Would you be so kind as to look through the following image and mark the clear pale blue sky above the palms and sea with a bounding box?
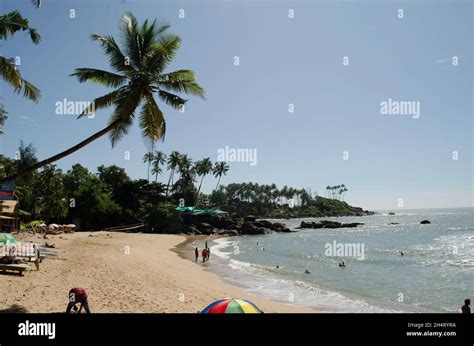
[0,0,474,210]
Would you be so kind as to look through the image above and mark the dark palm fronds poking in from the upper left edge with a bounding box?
[0,11,41,102]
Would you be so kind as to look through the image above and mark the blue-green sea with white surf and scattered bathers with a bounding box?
[202,208,474,313]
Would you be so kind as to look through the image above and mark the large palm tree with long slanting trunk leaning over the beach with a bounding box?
[0,13,204,182]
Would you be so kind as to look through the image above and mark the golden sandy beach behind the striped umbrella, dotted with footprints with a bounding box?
[0,232,311,313]
